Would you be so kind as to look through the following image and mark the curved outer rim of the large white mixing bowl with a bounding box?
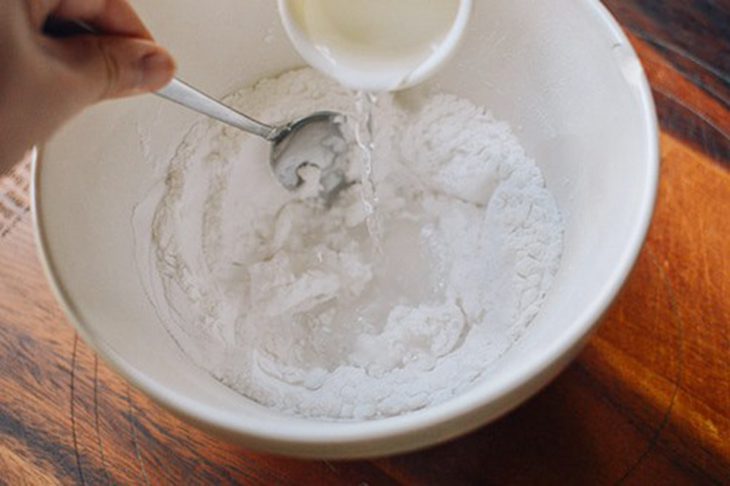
[31,0,660,458]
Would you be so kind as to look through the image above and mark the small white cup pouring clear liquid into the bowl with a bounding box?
[278,0,472,92]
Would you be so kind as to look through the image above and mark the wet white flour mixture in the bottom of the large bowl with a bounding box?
[141,69,562,419]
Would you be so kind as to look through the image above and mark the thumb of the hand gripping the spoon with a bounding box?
[54,36,175,103]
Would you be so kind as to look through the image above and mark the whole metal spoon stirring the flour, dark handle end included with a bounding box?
[43,17,350,197]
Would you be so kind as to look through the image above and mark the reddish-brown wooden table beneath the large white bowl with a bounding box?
[0,0,730,484]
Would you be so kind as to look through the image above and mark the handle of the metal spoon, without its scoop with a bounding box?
[43,17,280,141]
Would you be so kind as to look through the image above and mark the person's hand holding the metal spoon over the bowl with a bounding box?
[0,0,175,174]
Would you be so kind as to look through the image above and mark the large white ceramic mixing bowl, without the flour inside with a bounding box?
[34,0,659,457]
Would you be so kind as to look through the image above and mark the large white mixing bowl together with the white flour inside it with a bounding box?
[34,0,658,457]
